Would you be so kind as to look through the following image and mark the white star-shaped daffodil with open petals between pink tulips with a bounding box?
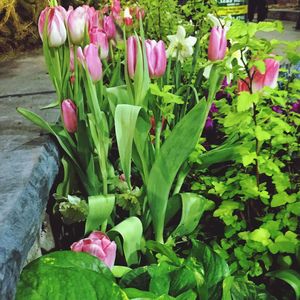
[167,25,197,62]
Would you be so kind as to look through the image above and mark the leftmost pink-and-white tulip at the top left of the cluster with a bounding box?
[38,6,67,47]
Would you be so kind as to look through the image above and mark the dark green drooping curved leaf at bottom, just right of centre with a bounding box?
[191,240,229,289]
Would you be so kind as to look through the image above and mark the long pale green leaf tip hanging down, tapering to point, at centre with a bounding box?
[115,104,141,186]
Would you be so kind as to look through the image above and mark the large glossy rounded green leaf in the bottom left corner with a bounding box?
[16,251,128,300]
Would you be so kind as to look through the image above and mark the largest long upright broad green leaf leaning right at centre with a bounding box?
[147,101,206,242]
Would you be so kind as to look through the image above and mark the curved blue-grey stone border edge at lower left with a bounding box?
[0,136,60,300]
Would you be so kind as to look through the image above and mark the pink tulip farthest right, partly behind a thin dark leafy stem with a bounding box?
[251,58,279,93]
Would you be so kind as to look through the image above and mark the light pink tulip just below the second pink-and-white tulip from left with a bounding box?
[77,44,102,82]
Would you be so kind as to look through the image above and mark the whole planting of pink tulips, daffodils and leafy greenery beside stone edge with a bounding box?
[17,0,300,300]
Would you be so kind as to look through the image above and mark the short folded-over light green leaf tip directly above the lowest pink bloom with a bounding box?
[85,195,115,233]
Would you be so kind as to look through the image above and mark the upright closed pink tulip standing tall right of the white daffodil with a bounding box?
[208,26,227,61]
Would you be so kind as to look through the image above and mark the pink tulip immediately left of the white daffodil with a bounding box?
[145,40,167,78]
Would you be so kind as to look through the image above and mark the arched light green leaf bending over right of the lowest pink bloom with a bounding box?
[108,217,143,266]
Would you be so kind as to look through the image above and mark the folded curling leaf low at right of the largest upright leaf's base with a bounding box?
[172,193,208,236]
